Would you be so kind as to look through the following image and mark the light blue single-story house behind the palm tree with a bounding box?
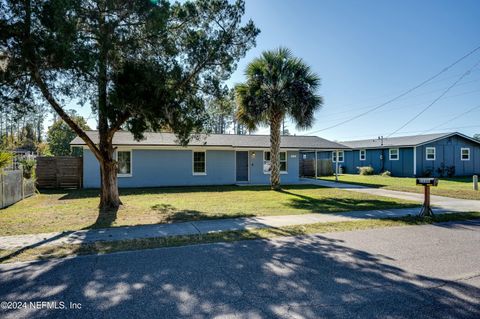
[70,131,347,188]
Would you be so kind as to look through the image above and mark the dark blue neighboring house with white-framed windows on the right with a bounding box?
[318,132,480,177]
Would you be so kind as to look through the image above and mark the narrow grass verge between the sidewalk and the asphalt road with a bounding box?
[0,212,480,263]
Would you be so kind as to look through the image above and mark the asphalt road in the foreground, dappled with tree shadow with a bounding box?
[0,221,480,319]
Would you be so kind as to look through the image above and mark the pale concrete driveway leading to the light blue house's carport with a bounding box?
[301,178,480,212]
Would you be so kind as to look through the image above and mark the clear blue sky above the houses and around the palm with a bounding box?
[72,0,480,141]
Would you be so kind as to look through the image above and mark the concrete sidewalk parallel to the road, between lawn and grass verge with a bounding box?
[0,208,449,250]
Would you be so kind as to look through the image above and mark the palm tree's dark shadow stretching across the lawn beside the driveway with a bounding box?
[280,189,418,213]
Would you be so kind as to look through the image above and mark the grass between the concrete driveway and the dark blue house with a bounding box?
[320,174,480,199]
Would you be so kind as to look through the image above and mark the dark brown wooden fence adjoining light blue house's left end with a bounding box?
[36,156,83,188]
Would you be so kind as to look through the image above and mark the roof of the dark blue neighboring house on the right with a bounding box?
[340,132,480,149]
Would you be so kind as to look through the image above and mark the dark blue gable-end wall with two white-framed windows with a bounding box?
[417,136,480,176]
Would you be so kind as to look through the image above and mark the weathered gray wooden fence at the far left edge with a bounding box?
[0,170,35,208]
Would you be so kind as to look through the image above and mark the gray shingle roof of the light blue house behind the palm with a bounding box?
[70,131,348,150]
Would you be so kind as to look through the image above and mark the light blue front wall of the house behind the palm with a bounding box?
[83,149,299,188]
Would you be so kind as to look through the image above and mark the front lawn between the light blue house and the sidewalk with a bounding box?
[0,185,418,236]
